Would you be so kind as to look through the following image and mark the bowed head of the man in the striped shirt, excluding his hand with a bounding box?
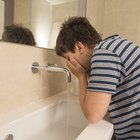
[55,17,102,70]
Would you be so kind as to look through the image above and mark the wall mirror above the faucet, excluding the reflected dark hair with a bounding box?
[0,0,85,49]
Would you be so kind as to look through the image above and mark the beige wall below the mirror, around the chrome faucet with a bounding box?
[0,42,68,117]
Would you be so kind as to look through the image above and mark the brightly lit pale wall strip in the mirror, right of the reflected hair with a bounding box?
[30,0,52,48]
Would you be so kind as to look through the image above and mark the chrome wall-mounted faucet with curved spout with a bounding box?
[31,62,71,83]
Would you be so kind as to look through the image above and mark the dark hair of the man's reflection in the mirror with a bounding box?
[1,24,36,46]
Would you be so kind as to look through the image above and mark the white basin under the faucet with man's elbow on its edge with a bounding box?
[0,93,113,140]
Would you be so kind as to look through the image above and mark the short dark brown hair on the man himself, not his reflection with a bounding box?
[55,17,102,56]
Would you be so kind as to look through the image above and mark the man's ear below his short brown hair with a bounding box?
[75,41,86,54]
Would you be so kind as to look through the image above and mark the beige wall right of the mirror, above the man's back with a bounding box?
[87,0,140,44]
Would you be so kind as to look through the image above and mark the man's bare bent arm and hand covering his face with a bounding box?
[67,60,111,123]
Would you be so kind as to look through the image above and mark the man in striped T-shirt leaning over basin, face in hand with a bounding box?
[55,17,140,140]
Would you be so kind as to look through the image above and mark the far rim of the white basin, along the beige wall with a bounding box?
[0,92,79,131]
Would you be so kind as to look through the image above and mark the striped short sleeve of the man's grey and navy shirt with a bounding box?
[87,49,123,94]
